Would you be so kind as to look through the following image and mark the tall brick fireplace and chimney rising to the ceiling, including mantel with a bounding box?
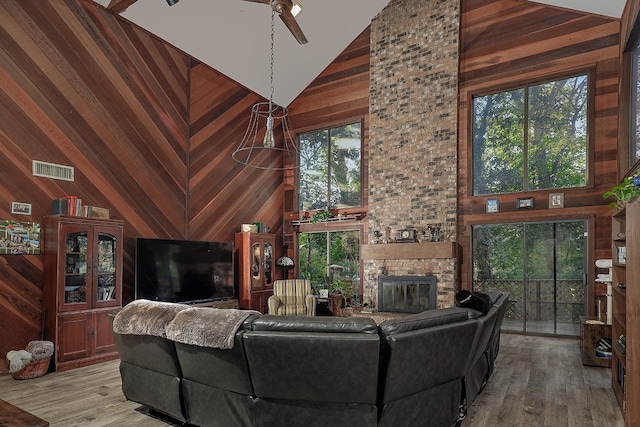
[361,0,460,308]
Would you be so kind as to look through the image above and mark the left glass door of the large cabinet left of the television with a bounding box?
[64,231,89,304]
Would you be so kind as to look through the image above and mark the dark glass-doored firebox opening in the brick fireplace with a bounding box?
[378,276,436,313]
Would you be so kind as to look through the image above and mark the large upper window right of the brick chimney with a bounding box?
[472,75,589,195]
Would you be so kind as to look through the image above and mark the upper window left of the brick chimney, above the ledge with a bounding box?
[298,122,362,211]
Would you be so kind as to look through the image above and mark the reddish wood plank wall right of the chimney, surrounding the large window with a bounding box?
[458,0,620,312]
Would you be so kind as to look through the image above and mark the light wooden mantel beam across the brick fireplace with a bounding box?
[360,242,459,260]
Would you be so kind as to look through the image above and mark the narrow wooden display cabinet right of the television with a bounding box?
[235,232,276,313]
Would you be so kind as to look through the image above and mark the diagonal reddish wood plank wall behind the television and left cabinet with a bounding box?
[0,0,283,371]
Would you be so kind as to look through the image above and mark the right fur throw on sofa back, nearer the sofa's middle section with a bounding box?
[167,307,260,349]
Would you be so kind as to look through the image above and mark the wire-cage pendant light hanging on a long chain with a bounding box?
[232,10,300,170]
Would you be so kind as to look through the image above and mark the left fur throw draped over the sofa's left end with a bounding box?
[113,299,190,338]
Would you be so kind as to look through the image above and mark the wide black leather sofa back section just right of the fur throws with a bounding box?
[242,315,380,410]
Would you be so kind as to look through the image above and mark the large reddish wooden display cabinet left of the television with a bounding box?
[42,215,123,372]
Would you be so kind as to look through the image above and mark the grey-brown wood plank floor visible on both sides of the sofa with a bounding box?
[0,334,624,427]
